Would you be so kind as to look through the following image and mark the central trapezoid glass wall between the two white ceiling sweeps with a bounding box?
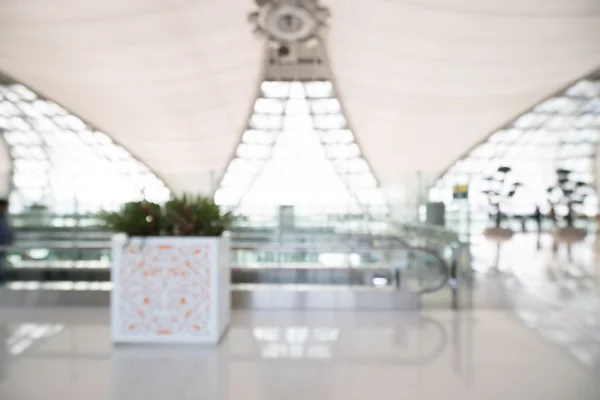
[215,81,387,218]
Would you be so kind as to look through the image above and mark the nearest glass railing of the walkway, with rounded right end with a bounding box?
[4,242,449,293]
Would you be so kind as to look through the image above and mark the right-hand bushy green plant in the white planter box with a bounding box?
[164,194,233,236]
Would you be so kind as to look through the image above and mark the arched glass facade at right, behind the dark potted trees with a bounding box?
[430,79,600,215]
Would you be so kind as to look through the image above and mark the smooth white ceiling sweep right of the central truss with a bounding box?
[327,0,600,185]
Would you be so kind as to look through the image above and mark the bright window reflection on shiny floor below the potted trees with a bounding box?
[472,234,600,370]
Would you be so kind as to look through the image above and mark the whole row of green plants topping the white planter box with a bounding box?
[98,194,233,236]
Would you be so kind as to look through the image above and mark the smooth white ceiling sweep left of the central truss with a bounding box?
[0,0,263,191]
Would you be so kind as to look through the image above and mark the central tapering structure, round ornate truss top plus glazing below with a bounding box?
[215,0,387,222]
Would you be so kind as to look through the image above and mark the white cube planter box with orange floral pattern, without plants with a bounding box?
[110,235,231,344]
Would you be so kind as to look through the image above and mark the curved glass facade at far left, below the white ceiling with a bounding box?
[0,79,170,214]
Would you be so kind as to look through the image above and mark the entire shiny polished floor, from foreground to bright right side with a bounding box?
[0,231,600,400]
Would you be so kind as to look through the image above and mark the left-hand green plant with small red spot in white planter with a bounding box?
[98,201,163,236]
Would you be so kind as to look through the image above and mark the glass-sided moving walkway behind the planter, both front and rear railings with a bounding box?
[1,211,468,293]
